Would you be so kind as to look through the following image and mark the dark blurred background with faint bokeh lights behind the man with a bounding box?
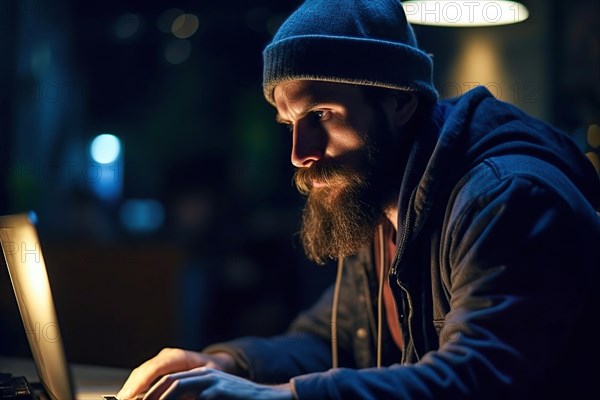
[0,0,600,367]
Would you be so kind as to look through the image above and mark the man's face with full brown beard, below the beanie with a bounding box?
[274,81,397,263]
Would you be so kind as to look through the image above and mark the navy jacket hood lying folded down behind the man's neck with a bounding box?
[398,86,600,238]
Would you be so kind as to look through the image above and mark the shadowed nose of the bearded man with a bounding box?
[291,121,326,168]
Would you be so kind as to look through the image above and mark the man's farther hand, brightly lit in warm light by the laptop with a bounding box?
[117,348,236,400]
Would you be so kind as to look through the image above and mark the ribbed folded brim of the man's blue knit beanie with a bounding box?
[263,35,438,104]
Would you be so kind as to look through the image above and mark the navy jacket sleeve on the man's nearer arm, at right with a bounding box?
[292,168,600,399]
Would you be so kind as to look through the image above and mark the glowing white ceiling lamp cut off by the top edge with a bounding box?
[402,0,529,27]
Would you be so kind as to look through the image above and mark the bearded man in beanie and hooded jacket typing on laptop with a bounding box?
[119,0,600,399]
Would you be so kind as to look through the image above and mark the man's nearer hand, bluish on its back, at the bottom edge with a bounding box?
[139,367,294,400]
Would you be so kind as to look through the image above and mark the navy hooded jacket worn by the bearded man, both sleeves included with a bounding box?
[205,87,600,400]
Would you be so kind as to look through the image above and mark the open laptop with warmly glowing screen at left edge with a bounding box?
[0,212,131,400]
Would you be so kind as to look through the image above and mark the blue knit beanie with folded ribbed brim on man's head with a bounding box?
[263,0,438,104]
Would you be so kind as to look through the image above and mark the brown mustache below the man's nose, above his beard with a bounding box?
[293,161,366,196]
